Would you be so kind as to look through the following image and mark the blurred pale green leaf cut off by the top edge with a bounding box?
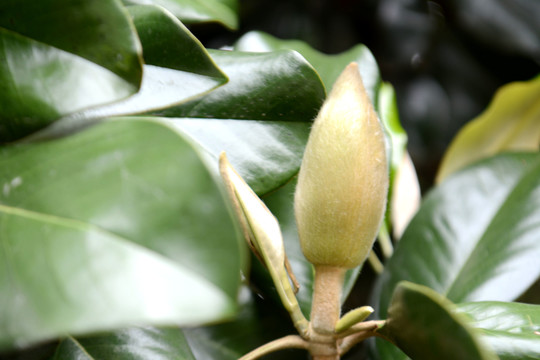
[123,0,238,29]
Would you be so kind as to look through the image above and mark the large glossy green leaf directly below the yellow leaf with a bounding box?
[374,154,540,359]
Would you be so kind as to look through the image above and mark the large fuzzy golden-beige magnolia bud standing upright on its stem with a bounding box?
[294,63,389,268]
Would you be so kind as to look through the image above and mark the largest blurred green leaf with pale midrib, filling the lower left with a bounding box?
[0,119,243,347]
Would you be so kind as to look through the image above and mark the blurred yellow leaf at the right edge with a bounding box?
[437,76,540,182]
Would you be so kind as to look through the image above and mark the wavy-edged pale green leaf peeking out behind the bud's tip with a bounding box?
[234,31,381,98]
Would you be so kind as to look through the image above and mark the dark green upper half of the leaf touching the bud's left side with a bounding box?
[154,50,325,122]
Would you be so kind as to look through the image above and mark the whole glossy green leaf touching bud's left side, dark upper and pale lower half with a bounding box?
[149,51,324,194]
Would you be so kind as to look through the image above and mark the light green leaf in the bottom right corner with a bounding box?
[457,302,540,360]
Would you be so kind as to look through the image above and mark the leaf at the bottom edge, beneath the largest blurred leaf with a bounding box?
[51,327,195,360]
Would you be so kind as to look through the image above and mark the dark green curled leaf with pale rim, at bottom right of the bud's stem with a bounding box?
[381,282,497,360]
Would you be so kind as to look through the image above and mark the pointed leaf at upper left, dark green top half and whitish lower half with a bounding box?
[47,5,227,125]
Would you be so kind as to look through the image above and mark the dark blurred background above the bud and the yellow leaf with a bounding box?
[193,0,540,190]
